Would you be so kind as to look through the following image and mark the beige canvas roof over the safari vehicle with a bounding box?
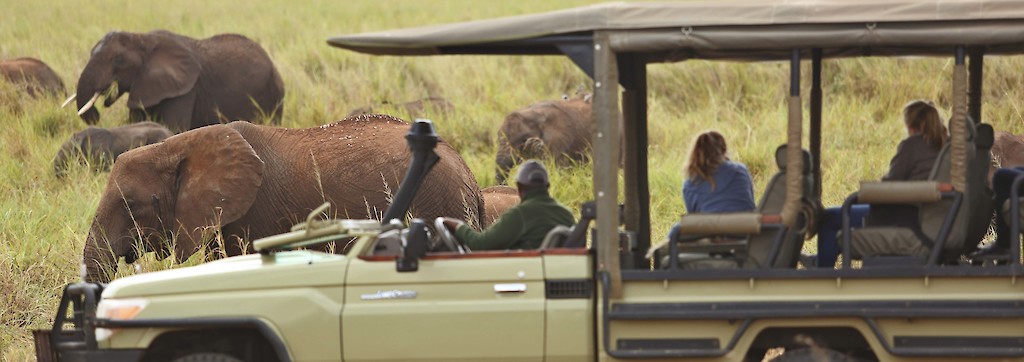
[328,0,1024,61]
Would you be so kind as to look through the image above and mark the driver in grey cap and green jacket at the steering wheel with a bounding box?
[444,160,575,251]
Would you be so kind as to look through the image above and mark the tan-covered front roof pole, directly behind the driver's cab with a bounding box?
[593,32,623,299]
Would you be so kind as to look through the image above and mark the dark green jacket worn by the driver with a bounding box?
[455,189,575,251]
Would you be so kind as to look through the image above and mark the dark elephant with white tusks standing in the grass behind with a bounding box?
[76,31,285,132]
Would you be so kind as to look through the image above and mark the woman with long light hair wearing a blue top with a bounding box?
[683,131,754,213]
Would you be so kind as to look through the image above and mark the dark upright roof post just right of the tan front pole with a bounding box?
[617,54,650,269]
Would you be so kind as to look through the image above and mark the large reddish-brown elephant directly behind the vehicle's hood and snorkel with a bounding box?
[83,115,483,281]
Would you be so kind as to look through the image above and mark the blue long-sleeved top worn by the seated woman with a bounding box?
[683,161,755,213]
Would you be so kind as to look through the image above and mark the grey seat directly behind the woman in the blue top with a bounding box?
[743,144,814,268]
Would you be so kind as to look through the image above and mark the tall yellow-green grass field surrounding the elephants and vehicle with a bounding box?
[0,0,1024,361]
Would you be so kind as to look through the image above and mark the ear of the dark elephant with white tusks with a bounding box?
[128,35,203,108]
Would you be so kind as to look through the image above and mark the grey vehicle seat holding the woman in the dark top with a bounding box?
[850,119,993,267]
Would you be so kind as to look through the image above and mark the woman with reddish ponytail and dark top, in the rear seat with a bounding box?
[803,99,948,268]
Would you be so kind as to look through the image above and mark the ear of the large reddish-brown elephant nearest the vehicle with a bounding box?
[164,125,264,262]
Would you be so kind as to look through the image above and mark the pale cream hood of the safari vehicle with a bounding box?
[102,251,348,299]
